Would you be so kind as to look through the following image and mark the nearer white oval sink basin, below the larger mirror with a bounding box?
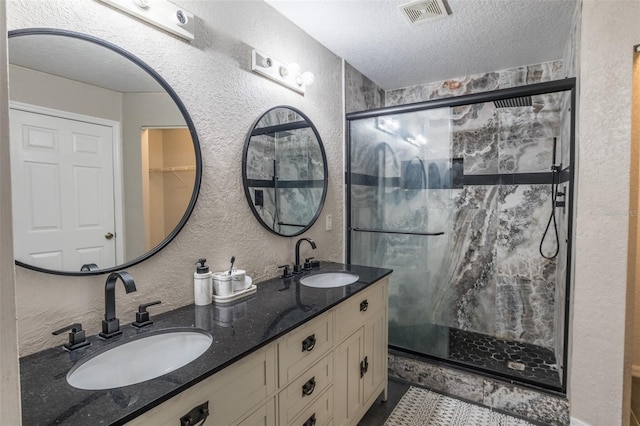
[67,328,213,390]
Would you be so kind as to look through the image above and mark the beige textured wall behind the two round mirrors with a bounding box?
[3,0,343,355]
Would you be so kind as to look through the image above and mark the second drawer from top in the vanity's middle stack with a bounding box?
[278,353,333,423]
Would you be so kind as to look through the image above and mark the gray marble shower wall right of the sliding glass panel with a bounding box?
[441,91,561,348]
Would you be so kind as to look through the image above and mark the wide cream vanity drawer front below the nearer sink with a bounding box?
[128,345,276,426]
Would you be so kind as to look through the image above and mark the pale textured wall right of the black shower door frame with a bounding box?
[570,0,640,426]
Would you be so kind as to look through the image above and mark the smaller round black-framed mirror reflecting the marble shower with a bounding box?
[242,106,327,237]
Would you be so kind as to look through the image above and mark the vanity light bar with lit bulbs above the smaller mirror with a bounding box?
[251,49,315,95]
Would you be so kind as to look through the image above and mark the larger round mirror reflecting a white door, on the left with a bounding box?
[9,28,202,275]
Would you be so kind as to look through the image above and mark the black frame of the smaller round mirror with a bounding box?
[242,105,329,237]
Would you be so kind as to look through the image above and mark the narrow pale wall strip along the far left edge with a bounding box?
[0,2,20,425]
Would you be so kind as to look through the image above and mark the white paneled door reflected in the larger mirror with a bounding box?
[9,109,116,271]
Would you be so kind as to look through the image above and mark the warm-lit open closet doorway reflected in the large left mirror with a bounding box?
[141,127,196,250]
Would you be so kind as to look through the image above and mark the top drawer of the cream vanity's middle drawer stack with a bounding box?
[278,313,333,387]
